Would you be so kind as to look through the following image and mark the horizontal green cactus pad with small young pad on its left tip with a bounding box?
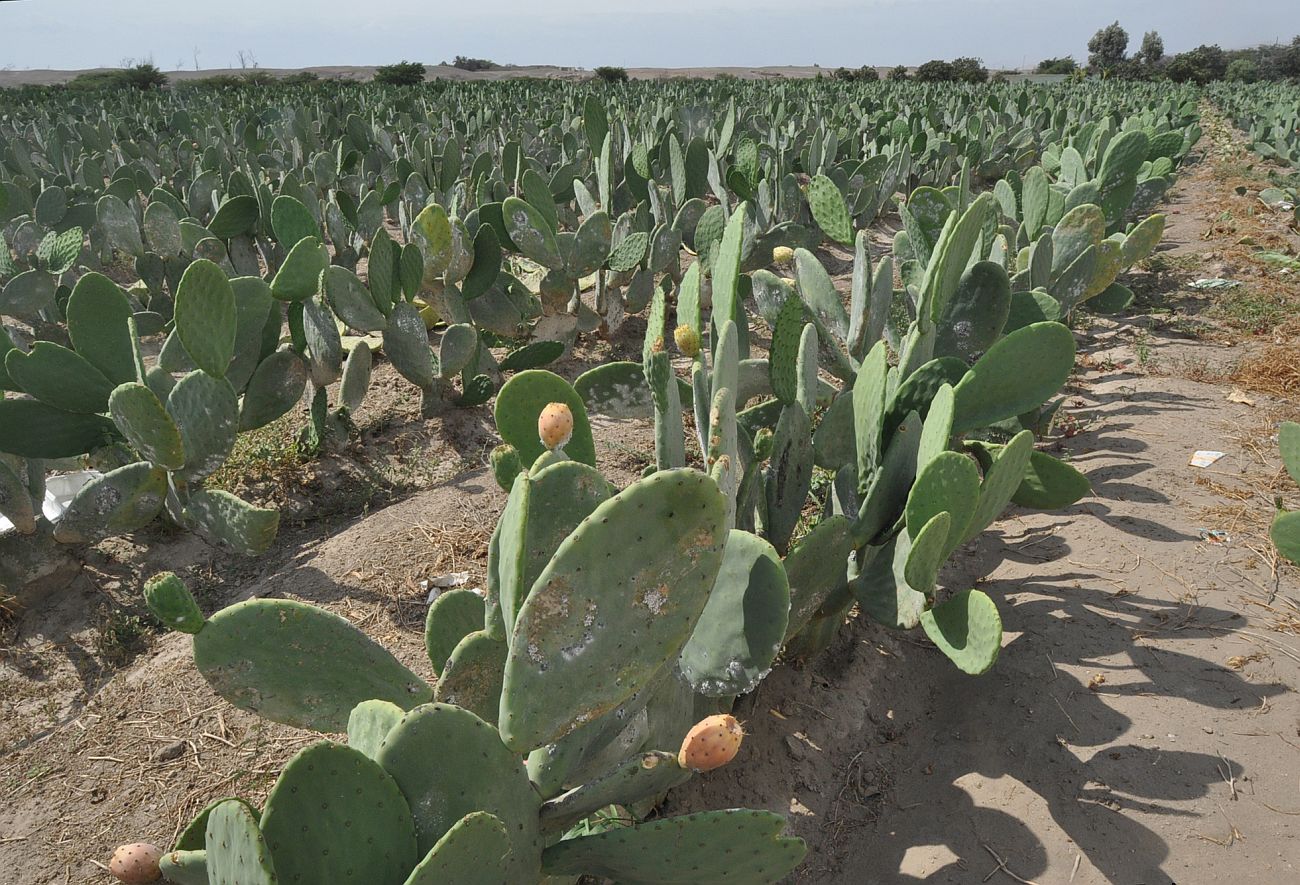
[194,599,433,732]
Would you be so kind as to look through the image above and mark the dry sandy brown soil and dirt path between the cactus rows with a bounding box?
[0,107,1300,885]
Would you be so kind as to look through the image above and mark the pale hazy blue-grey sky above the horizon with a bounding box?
[0,0,1300,70]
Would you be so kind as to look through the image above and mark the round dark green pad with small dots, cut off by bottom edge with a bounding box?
[261,741,420,885]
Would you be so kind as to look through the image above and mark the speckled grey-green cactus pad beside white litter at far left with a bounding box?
[55,461,166,543]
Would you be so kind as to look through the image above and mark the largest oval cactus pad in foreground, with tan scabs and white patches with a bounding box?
[499,469,727,751]
